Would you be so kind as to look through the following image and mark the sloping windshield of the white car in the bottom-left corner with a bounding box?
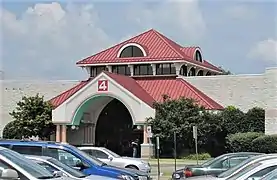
[0,149,53,179]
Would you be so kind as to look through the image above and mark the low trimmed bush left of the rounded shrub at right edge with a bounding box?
[226,132,263,152]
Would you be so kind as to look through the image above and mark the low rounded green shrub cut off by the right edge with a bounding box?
[252,135,277,153]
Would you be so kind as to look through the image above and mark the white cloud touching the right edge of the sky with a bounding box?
[248,39,277,62]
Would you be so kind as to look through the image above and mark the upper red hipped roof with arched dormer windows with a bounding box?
[76,29,221,71]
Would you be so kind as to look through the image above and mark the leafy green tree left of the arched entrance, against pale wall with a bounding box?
[7,94,54,138]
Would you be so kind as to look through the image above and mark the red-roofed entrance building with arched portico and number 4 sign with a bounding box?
[50,29,226,156]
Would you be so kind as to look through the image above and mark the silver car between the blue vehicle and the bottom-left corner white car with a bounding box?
[25,155,115,180]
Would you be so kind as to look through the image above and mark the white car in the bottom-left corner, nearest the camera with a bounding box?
[0,147,72,180]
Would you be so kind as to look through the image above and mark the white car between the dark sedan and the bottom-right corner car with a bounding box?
[227,158,277,180]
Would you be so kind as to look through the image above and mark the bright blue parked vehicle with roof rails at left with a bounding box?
[0,140,140,180]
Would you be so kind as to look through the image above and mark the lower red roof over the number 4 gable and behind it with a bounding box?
[50,72,223,109]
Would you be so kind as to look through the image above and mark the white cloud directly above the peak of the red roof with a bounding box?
[125,0,206,39]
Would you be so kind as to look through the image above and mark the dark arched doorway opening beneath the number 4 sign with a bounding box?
[95,99,142,156]
